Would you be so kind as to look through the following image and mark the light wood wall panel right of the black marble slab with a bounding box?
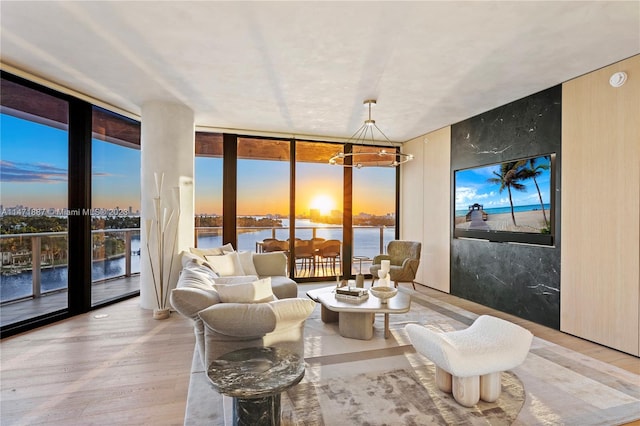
[560,56,640,355]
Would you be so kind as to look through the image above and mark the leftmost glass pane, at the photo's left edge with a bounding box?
[0,78,70,328]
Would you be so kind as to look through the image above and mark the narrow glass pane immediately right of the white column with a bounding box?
[194,132,223,248]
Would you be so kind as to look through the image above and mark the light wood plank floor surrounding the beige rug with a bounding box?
[0,284,640,426]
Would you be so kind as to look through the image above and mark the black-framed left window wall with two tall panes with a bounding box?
[0,71,140,337]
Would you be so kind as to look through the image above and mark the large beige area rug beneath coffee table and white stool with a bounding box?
[185,284,640,426]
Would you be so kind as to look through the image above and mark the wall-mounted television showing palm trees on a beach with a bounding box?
[453,154,555,245]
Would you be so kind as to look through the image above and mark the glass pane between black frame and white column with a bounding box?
[91,107,140,305]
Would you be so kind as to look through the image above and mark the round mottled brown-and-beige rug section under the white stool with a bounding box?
[282,365,525,426]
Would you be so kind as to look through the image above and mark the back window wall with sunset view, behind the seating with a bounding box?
[195,133,397,281]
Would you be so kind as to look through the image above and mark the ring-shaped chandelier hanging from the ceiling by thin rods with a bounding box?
[329,99,413,169]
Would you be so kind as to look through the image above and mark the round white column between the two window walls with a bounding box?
[140,101,195,309]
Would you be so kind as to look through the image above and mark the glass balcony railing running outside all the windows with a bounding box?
[0,226,395,304]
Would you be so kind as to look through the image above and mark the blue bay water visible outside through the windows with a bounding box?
[0,223,395,302]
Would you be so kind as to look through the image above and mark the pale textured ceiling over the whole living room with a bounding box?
[0,0,640,142]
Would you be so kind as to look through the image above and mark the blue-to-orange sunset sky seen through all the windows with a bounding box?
[0,114,395,215]
